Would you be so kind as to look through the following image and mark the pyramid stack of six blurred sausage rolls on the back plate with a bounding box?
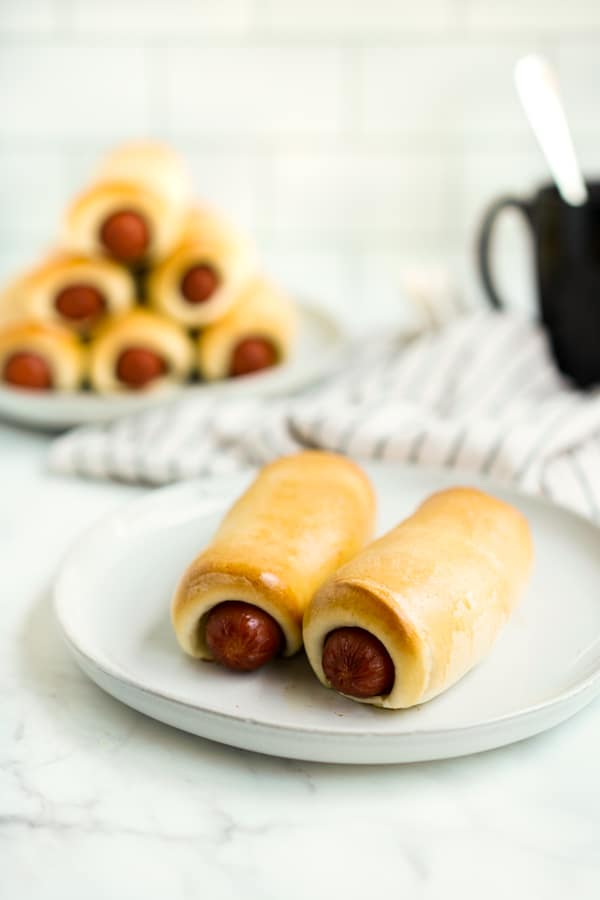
[0,142,296,394]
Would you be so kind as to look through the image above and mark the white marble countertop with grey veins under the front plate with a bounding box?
[0,425,600,900]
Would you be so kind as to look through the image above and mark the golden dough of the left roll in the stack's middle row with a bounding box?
[0,253,135,333]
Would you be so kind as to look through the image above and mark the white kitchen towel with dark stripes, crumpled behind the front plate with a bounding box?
[50,312,600,521]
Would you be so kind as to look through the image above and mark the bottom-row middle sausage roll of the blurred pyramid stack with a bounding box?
[90,309,194,394]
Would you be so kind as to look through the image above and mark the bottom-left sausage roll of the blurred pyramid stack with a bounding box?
[0,321,86,391]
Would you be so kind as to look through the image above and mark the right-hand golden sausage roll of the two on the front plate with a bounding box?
[304,488,533,709]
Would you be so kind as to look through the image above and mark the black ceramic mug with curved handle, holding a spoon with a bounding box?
[478,182,600,387]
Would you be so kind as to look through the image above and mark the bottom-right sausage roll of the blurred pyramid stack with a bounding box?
[198,278,297,381]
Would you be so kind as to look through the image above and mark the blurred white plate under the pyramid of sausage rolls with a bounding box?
[0,304,345,429]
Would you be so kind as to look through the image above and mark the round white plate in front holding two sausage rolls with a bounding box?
[55,463,600,763]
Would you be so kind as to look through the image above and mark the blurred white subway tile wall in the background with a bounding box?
[0,0,600,330]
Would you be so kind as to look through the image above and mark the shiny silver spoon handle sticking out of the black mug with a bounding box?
[515,54,588,206]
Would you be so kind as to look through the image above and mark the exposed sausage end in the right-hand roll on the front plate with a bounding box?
[322,628,395,698]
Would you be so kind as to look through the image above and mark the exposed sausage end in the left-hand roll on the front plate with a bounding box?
[206,600,283,672]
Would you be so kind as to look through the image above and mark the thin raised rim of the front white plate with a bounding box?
[52,459,600,752]
